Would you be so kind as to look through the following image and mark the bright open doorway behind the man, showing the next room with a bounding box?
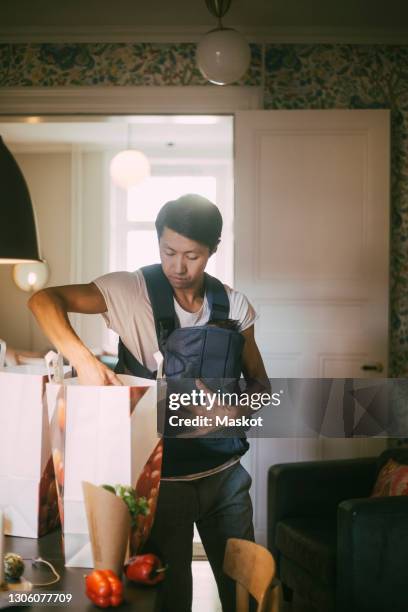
[0,115,234,353]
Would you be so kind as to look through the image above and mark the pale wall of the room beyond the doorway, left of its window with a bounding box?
[0,151,108,350]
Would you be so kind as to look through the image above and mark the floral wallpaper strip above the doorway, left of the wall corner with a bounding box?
[0,43,261,87]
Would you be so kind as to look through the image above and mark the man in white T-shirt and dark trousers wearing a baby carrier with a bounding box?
[29,195,268,612]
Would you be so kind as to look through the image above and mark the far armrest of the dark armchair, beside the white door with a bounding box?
[268,457,376,554]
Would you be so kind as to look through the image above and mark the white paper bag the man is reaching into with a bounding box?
[47,375,161,567]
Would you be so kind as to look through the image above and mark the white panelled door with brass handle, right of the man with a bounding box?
[234,110,390,542]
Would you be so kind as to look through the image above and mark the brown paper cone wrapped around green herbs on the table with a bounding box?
[82,482,130,576]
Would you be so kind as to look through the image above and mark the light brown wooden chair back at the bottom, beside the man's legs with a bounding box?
[223,538,279,612]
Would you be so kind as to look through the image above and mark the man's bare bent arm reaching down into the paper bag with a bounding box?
[28,283,121,385]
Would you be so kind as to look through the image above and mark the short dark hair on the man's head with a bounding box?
[156,193,222,253]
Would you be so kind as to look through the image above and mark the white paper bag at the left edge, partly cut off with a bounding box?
[0,341,68,538]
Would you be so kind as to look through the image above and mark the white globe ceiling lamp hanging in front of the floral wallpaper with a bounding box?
[197,28,251,85]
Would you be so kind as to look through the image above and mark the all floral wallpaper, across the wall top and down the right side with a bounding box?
[0,43,408,377]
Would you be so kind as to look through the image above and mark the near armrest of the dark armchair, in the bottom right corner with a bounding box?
[336,496,408,612]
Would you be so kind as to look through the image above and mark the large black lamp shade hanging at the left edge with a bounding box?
[0,136,40,264]
